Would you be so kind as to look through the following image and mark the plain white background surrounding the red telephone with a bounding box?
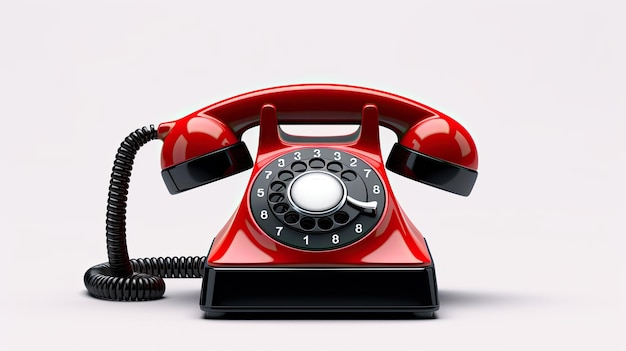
[0,0,626,350]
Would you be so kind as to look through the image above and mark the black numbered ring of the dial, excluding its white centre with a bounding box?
[250,148,385,251]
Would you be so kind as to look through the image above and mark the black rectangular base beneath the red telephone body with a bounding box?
[200,266,439,318]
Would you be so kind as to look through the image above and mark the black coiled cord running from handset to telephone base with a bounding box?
[84,125,206,301]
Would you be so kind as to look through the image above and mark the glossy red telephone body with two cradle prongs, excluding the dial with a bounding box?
[207,105,431,267]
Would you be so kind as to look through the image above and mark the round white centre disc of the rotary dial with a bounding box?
[287,171,346,214]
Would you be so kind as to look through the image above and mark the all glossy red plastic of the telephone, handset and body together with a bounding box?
[158,84,478,267]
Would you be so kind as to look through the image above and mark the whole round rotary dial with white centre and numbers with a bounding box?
[250,148,385,251]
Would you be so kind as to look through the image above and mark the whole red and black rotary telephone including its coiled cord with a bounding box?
[85,84,478,317]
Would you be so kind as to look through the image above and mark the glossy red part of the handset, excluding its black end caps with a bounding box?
[159,84,478,169]
